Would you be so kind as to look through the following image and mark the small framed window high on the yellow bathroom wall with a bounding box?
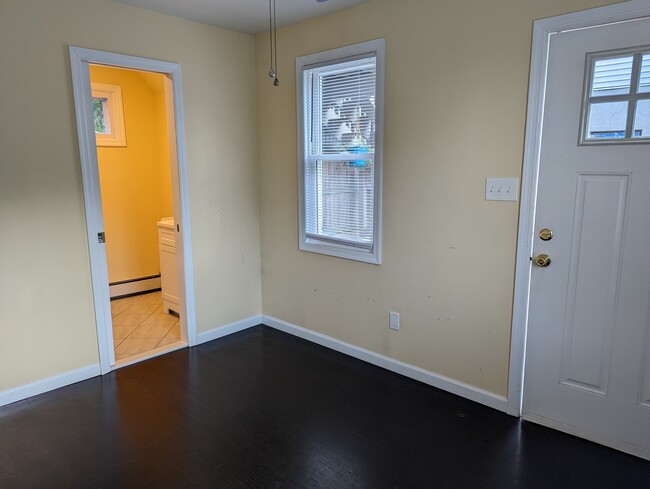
[91,83,126,146]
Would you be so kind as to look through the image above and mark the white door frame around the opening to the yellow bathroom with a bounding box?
[70,46,197,375]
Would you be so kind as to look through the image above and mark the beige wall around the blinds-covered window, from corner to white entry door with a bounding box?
[256,0,607,395]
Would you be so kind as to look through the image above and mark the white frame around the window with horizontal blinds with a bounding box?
[296,39,385,265]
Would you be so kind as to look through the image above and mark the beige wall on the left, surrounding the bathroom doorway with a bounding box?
[0,0,261,391]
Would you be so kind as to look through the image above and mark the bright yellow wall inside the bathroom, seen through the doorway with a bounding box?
[90,66,173,283]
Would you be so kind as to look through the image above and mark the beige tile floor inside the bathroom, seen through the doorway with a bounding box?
[111,291,181,360]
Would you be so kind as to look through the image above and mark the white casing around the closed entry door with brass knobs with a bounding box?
[506,0,650,416]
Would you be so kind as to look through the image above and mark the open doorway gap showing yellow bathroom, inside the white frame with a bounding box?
[89,64,185,366]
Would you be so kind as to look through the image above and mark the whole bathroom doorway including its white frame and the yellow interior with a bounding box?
[70,47,196,373]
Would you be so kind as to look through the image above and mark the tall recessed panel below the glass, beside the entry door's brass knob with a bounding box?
[561,174,629,394]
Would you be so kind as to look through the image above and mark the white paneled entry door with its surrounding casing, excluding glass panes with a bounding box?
[508,1,650,458]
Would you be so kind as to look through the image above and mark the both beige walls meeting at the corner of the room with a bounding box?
[0,0,608,395]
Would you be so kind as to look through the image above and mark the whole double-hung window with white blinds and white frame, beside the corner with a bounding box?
[297,40,383,263]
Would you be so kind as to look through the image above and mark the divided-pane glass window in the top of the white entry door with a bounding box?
[581,46,650,144]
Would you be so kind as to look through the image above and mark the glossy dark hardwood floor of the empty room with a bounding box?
[0,326,650,489]
